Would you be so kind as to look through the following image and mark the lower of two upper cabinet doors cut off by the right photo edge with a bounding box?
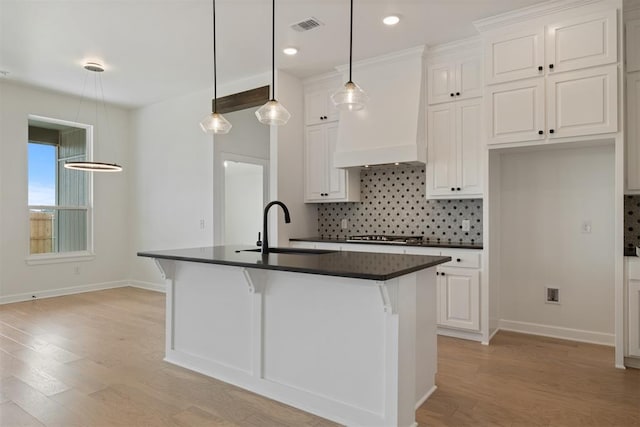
[625,72,640,190]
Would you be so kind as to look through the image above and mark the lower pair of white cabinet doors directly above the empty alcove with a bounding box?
[485,65,618,144]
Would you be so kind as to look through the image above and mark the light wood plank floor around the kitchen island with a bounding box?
[0,288,640,427]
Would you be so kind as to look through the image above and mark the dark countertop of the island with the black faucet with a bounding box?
[138,246,451,281]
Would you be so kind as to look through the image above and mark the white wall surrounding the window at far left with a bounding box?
[0,81,131,302]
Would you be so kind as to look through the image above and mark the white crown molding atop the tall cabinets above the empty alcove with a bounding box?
[473,0,602,33]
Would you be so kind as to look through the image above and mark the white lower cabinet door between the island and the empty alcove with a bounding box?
[438,267,480,331]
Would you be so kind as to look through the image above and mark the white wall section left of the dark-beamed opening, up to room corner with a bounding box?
[129,85,213,285]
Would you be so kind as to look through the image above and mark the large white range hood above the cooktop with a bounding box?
[334,46,426,168]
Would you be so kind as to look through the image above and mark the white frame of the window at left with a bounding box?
[25,114,95,265]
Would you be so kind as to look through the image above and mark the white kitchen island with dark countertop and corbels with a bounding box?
[138,246,450,427]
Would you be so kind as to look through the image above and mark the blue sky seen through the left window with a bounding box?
[28,142,57,206]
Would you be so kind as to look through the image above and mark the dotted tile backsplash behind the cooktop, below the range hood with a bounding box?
[318,166,482,243]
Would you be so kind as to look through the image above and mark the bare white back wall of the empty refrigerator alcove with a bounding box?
[498,145,615,344]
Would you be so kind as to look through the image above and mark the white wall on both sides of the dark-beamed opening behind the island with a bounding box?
[129,73,317,286]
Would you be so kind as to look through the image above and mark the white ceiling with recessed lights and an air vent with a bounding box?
[0,0,541,108]
